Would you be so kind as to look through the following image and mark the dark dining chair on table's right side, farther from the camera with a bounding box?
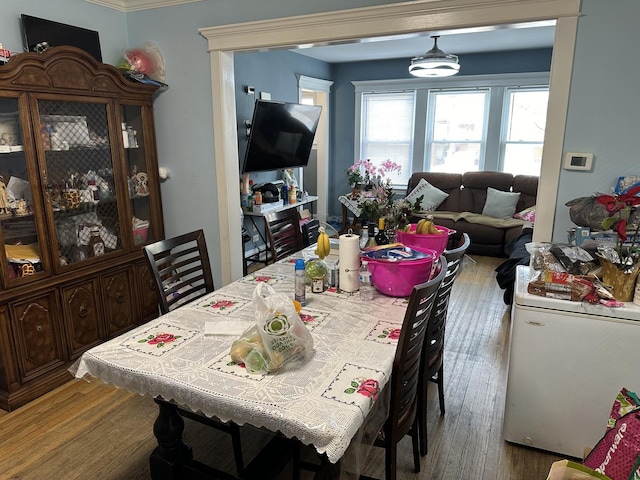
[418,233,471,456]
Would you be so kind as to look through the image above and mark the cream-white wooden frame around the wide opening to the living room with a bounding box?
[199,0,580,285]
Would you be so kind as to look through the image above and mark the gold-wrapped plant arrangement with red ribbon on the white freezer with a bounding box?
[596,185,640,272]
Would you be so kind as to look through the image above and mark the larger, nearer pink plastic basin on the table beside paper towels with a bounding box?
[362,247,440,297]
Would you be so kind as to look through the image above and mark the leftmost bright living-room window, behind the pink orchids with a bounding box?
[360,92,415,185]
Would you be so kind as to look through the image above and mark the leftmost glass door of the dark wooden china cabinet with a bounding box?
[0,96,48,288]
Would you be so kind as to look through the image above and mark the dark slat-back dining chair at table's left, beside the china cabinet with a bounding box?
[144,230,244,475]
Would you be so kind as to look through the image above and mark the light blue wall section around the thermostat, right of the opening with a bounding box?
[553,0,640,241]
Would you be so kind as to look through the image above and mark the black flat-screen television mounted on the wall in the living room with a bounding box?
[242,100,322,173]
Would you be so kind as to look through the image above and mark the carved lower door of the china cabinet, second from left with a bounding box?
[62,280,105,359]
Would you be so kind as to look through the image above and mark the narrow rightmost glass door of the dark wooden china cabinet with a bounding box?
[120,105,157,245]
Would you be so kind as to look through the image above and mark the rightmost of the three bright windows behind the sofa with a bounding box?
[501,88,549,175]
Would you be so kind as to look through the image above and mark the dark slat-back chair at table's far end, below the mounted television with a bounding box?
[264,208,303,264]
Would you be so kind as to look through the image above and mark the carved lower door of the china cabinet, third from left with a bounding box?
[100,268,135,337]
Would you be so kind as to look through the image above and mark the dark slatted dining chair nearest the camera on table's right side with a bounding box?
[361,256,447,480]
